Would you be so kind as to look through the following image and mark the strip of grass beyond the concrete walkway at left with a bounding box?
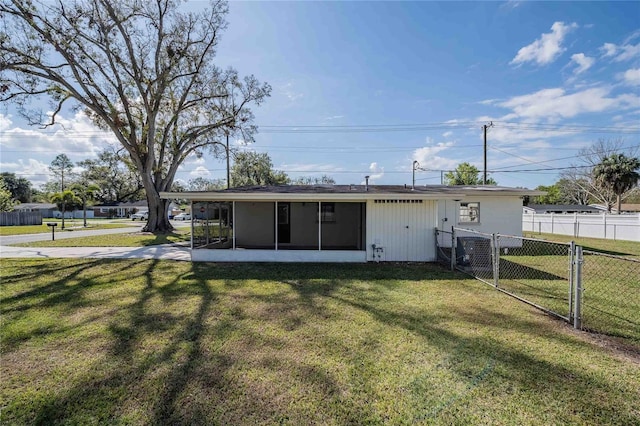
[14,230,190,247]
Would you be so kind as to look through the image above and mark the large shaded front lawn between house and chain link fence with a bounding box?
[0,259,640,425]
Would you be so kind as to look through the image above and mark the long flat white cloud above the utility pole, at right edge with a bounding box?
[499,87,640,119]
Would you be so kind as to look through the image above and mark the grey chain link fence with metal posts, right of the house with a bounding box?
[436,227,640,346]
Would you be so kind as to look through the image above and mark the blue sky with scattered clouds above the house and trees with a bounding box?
[0,2,640,188]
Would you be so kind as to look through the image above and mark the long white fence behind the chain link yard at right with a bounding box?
[522,213,640,241]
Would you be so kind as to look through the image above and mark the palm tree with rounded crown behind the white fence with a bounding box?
[593,154,640,214]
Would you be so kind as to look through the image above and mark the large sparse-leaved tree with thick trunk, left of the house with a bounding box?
[0,0,271,231]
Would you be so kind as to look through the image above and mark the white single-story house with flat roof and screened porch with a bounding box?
[160,185,544,262]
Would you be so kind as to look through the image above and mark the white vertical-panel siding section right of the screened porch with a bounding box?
[367,196,436,262]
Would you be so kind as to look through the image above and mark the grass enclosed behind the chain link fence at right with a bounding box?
[500,235,640,347]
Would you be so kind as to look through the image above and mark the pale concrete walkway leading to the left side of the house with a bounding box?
[0,244,191,261]
